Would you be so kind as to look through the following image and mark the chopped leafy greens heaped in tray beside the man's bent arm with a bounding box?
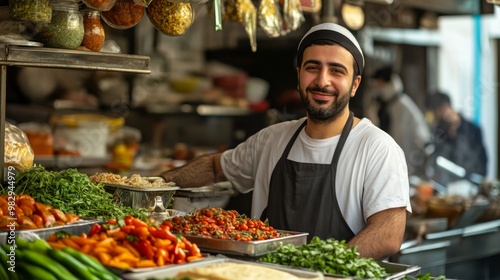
[259,236,389,279]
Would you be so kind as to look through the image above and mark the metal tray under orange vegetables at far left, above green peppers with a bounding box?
[0,219,102,244]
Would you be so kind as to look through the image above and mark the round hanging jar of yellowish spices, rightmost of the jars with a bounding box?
[146,0,194,36]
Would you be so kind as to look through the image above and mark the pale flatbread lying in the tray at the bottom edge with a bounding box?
[176,262,318,280]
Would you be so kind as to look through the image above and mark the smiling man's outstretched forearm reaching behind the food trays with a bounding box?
[161,154,224,188]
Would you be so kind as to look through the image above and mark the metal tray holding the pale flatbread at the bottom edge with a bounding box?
[121,257,324,280]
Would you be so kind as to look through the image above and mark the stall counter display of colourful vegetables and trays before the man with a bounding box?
[0,166,420,279]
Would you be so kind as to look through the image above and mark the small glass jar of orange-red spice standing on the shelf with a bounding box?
[81,9,105,52]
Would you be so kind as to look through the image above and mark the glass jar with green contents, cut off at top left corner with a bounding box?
[9,0,52,22]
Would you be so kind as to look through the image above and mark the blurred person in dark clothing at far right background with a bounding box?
[427,91,488,186]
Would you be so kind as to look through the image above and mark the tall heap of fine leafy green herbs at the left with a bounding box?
[0,165,146,220]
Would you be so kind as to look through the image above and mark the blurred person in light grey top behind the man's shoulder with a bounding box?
[371,66,432,177]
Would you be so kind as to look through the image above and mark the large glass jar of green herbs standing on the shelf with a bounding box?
[36,0,85,50]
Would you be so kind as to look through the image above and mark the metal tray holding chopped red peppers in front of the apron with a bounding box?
[184,230,308,257]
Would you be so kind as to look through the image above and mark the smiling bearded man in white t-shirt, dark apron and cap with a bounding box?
[162,23,411,259]
